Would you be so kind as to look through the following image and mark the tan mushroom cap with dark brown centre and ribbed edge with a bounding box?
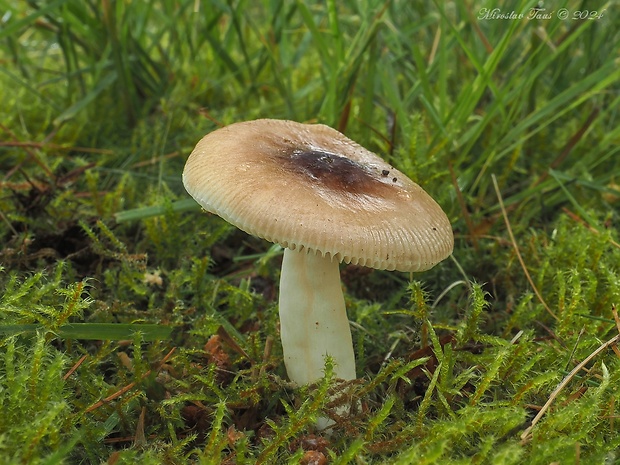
[183,119,454,271]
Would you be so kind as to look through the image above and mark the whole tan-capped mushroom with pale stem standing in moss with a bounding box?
[183,119,454,416]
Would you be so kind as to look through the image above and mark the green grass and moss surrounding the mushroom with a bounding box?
[0,0,620,464]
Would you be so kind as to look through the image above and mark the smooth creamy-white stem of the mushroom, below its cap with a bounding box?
[280,249,355,385]
